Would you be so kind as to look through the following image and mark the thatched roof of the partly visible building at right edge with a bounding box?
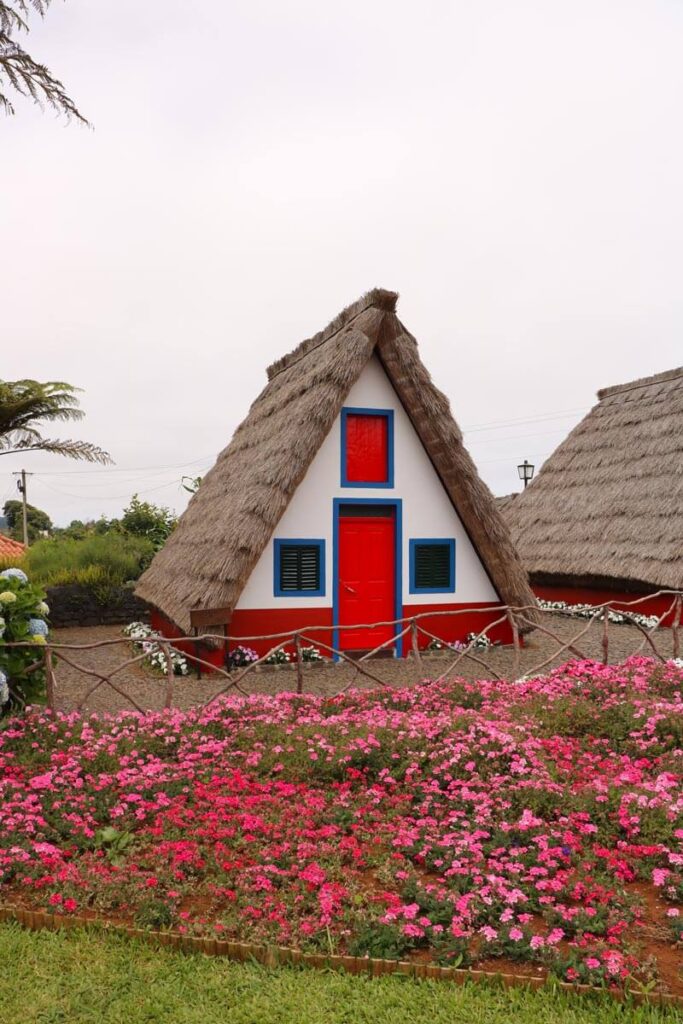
[505,367,683,590]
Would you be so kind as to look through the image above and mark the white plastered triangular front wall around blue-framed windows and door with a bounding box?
[237,356,498,609]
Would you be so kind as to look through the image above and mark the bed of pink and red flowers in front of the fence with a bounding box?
[0,657,683,989]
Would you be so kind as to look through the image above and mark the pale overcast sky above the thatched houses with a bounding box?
[0,0,683,524]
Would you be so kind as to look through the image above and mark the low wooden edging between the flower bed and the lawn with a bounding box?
[0,904,683,1009]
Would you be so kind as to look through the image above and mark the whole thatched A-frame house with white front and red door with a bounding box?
[137,289,532,653]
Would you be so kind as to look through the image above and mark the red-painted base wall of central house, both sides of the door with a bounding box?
[151,603,512,672]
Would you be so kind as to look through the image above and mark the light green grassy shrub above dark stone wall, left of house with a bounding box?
[24,534,154,590]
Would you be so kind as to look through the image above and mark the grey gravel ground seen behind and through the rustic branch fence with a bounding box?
[46,614,672,712]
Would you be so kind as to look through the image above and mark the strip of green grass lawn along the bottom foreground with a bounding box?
[0,925,683,1024]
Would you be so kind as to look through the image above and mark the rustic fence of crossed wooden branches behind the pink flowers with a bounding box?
[7,590,683,713]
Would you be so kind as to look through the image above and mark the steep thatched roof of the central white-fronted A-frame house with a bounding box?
[136,289,533,632]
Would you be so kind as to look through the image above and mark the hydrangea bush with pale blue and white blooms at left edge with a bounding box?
[0,568,49,715]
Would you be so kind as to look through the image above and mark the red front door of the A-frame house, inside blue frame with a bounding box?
[338,506,397,650]
